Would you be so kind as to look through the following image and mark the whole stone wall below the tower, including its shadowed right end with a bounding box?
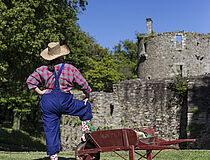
[61,75,210,150]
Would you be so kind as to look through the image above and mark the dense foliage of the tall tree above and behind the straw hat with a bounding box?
[0,0,87,81]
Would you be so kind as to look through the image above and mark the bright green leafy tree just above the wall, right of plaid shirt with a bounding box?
[85,45,124,92]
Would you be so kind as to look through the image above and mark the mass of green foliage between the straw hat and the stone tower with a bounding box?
[71,39,137,92]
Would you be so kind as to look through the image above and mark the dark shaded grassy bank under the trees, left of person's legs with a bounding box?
[0,128,46,152]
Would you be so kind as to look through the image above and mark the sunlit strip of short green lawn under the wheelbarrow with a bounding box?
[0,150,210,160]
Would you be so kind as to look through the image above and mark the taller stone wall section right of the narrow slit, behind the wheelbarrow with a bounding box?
[114,79,185,140]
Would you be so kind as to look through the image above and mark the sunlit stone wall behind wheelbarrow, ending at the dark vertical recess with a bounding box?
[61,79,187,150]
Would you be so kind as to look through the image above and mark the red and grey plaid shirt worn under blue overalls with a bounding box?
[26,63,91,93]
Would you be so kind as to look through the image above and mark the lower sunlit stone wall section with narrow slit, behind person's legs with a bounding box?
[61,92,121,150]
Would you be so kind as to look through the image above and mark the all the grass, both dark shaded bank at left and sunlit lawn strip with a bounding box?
[0,128,210,160]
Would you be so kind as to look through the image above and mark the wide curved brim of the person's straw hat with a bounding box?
[40,45,70,61]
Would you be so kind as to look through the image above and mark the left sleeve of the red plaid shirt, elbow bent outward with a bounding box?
[26,69,41,89]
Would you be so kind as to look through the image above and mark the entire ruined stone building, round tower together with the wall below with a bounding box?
[61,19,210,150]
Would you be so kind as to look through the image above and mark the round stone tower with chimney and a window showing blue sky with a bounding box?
[138,19,210,79]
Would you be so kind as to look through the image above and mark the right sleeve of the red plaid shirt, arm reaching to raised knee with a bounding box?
[73,67,92,93]
